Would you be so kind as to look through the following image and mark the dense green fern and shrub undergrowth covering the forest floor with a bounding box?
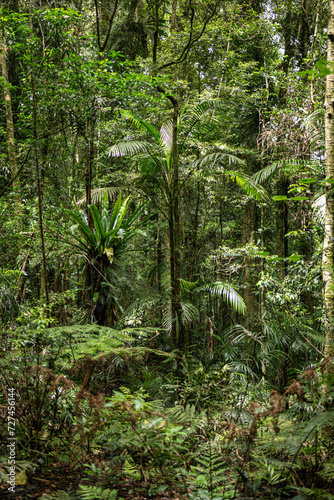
[0,307,334,500]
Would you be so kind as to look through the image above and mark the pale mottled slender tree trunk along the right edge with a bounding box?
[322,0,334,357]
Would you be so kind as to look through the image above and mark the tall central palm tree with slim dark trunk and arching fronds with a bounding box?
[110,101,264,351]
